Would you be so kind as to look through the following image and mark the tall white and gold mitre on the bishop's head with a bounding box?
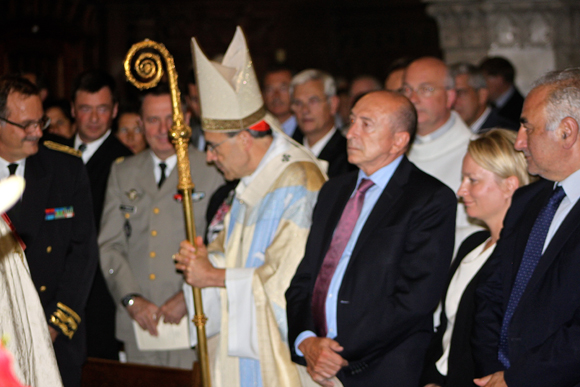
[191,26,266,132]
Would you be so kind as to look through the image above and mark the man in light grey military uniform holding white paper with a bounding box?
[99,84,223,368]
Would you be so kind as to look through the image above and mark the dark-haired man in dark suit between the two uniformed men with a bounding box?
[47,71,132,360]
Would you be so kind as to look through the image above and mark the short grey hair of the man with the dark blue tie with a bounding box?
[532,67,580,130]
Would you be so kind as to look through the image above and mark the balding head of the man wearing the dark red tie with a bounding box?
[346,91,417,176]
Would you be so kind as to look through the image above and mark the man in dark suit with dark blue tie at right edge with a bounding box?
[472,69,580,387]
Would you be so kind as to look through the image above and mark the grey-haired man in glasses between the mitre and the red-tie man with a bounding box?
[290,69,356,177]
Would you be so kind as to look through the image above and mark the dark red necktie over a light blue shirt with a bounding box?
[312,179,374,337]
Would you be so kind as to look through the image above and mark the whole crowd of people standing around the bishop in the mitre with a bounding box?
[0,28,580,387]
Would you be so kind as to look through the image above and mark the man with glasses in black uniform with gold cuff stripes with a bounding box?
[0,76,98,387]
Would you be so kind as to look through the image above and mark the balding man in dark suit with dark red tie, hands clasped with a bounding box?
[286,91,457,387]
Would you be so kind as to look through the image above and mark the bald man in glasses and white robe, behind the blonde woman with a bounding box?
[402,57,477,246]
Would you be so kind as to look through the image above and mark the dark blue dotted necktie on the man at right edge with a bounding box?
[497,186,566,368]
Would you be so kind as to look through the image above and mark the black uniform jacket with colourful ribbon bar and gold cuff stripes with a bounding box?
[8,145,98,386]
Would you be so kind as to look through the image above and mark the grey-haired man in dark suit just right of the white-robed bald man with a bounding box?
[449,62,520,134]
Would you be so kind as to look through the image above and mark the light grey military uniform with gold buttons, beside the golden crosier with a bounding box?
[99,147,224,368]
